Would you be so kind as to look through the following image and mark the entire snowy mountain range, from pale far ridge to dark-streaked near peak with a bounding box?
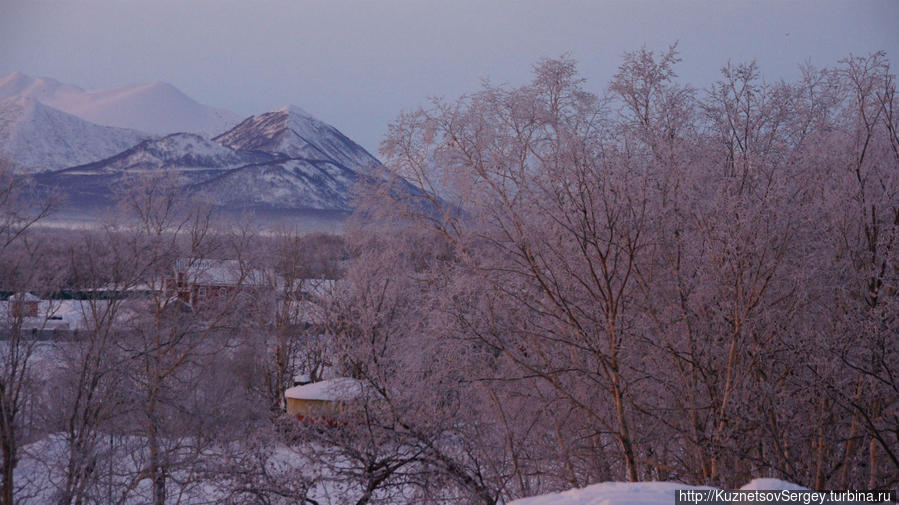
[0,74,415,219]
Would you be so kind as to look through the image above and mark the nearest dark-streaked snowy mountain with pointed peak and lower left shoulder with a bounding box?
[37,107,400,212]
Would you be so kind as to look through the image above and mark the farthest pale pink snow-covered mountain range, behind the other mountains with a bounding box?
[0,72,240,136]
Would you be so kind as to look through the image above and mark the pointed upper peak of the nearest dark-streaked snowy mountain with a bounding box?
[213,106,380,171]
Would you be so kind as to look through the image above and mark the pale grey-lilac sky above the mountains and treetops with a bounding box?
[0,0,899,153]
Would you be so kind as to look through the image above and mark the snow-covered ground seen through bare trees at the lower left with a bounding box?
[15,433,378,505]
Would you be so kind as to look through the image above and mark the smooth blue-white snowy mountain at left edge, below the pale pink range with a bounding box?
[0,97,148,173]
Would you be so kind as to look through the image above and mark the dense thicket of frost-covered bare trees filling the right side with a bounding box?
[357,47,899,496]
